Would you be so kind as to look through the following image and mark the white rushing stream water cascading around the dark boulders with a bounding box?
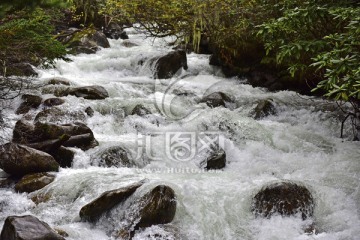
[0,30,360,240]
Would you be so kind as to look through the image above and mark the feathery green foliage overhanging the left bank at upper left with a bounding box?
[0,9,66,71]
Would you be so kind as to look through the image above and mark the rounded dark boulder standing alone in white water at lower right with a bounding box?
[252,182,314,220]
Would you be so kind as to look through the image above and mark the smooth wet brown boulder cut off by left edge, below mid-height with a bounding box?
[0,143,59,177]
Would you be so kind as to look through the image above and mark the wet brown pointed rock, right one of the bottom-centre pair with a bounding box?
[134,185,176,230]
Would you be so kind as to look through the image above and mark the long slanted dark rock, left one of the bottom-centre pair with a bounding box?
[80,182,143,222]
